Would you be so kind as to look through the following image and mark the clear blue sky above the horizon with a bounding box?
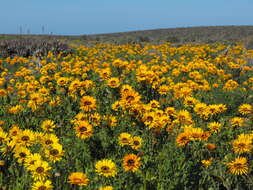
[0,0,253,35]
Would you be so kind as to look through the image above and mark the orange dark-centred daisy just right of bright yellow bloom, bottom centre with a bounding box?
[123,154,141,172]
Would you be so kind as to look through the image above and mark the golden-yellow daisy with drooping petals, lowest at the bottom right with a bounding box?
[226,157,249,175]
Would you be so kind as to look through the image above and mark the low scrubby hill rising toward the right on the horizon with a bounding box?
[86,26,253,43]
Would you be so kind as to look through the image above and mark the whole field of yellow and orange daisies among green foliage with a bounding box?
[0,43,253,190]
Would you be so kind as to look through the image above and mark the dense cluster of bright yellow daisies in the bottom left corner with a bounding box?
[0,120,64,190]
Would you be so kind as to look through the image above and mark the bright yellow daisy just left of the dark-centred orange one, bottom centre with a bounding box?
[95,159,117,177]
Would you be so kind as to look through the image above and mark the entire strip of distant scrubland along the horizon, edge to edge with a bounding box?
[0,26,253,46]
